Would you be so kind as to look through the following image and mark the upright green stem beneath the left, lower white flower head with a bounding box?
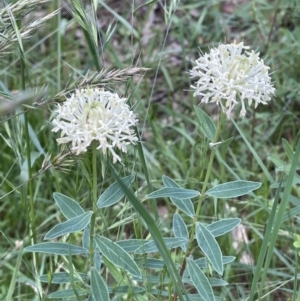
[90,141,97,267]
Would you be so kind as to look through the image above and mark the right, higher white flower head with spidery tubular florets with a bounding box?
[190,42,275,119]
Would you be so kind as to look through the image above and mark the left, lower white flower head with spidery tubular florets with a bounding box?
[52,88,138,163]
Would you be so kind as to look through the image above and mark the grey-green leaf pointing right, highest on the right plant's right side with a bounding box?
[206,181,261,199]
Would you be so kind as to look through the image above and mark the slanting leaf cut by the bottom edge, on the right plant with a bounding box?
[187,258,215,301]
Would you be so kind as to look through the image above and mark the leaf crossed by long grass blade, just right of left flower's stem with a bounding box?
[97,175,135,208]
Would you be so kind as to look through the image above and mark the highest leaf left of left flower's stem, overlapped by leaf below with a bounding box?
[53,192,84,219]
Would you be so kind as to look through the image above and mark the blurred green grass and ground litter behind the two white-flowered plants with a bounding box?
[0,0,300,300]
